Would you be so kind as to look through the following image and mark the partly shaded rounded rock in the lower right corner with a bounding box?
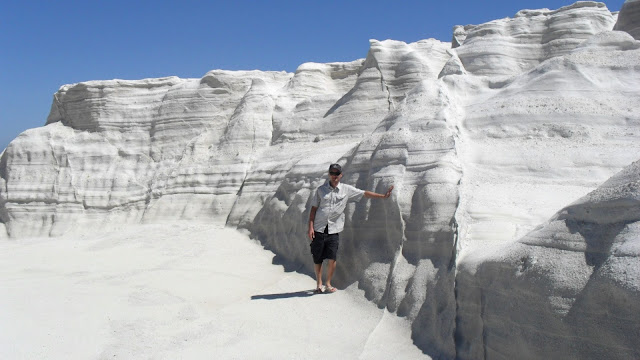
[456,161,640,359]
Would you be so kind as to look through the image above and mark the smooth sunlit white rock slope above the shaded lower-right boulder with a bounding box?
[452,28,640,250]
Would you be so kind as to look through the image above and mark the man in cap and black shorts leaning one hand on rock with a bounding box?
[309,164,393,294]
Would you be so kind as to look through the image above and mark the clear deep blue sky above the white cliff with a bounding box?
[0,0,624,151]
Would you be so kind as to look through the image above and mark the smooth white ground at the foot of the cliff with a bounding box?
[0,224,428,359]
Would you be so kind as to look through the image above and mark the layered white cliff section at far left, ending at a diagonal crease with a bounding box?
[2,71,291,236]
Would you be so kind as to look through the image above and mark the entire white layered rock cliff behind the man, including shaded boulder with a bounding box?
[0,1,640,359]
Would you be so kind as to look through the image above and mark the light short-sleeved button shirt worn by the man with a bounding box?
[311,181,364,234]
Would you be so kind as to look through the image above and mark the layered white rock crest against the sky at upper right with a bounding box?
[455,1,616,76]
